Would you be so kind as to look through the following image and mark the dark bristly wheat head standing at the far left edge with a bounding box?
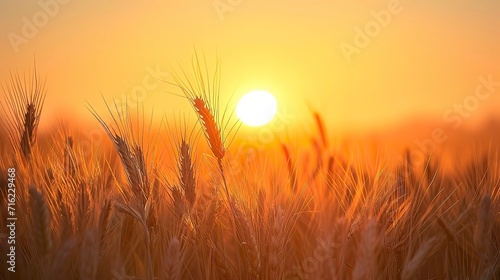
[2,66,46,160]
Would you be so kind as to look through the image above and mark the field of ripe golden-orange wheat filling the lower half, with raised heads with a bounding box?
[0,60,500,279]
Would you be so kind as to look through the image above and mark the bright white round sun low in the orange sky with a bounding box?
[236,90,278,126]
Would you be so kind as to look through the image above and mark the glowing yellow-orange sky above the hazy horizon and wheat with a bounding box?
[0,0,500,131]
